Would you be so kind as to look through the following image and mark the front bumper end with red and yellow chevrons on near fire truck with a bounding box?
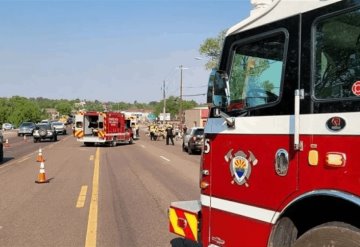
[168,200,201,242]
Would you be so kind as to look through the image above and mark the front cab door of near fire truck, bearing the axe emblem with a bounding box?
[202,16,301,246]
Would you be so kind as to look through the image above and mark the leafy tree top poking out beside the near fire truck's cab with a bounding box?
[199,30,226,70]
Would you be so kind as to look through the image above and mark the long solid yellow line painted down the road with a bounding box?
[85,148,100,247]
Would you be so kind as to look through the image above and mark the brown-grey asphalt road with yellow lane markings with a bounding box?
[0,128,200,247]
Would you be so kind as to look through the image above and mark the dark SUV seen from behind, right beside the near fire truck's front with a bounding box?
[182,127,204,154]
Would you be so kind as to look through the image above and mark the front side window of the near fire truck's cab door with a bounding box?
[226,31,286,115]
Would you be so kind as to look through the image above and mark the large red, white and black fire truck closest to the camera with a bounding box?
[169,0,360,247]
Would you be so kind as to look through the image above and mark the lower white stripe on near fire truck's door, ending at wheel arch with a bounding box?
[201,195,280,224]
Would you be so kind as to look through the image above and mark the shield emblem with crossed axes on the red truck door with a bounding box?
[224,149,258,187]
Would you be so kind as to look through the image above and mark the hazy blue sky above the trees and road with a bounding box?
[0,0,251,103]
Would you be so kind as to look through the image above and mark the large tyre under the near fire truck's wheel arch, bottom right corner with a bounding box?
[293,222,360,247]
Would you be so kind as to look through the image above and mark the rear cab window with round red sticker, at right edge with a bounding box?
[313,10,360,100]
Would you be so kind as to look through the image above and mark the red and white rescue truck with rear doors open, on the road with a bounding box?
[74,111,133,146]
